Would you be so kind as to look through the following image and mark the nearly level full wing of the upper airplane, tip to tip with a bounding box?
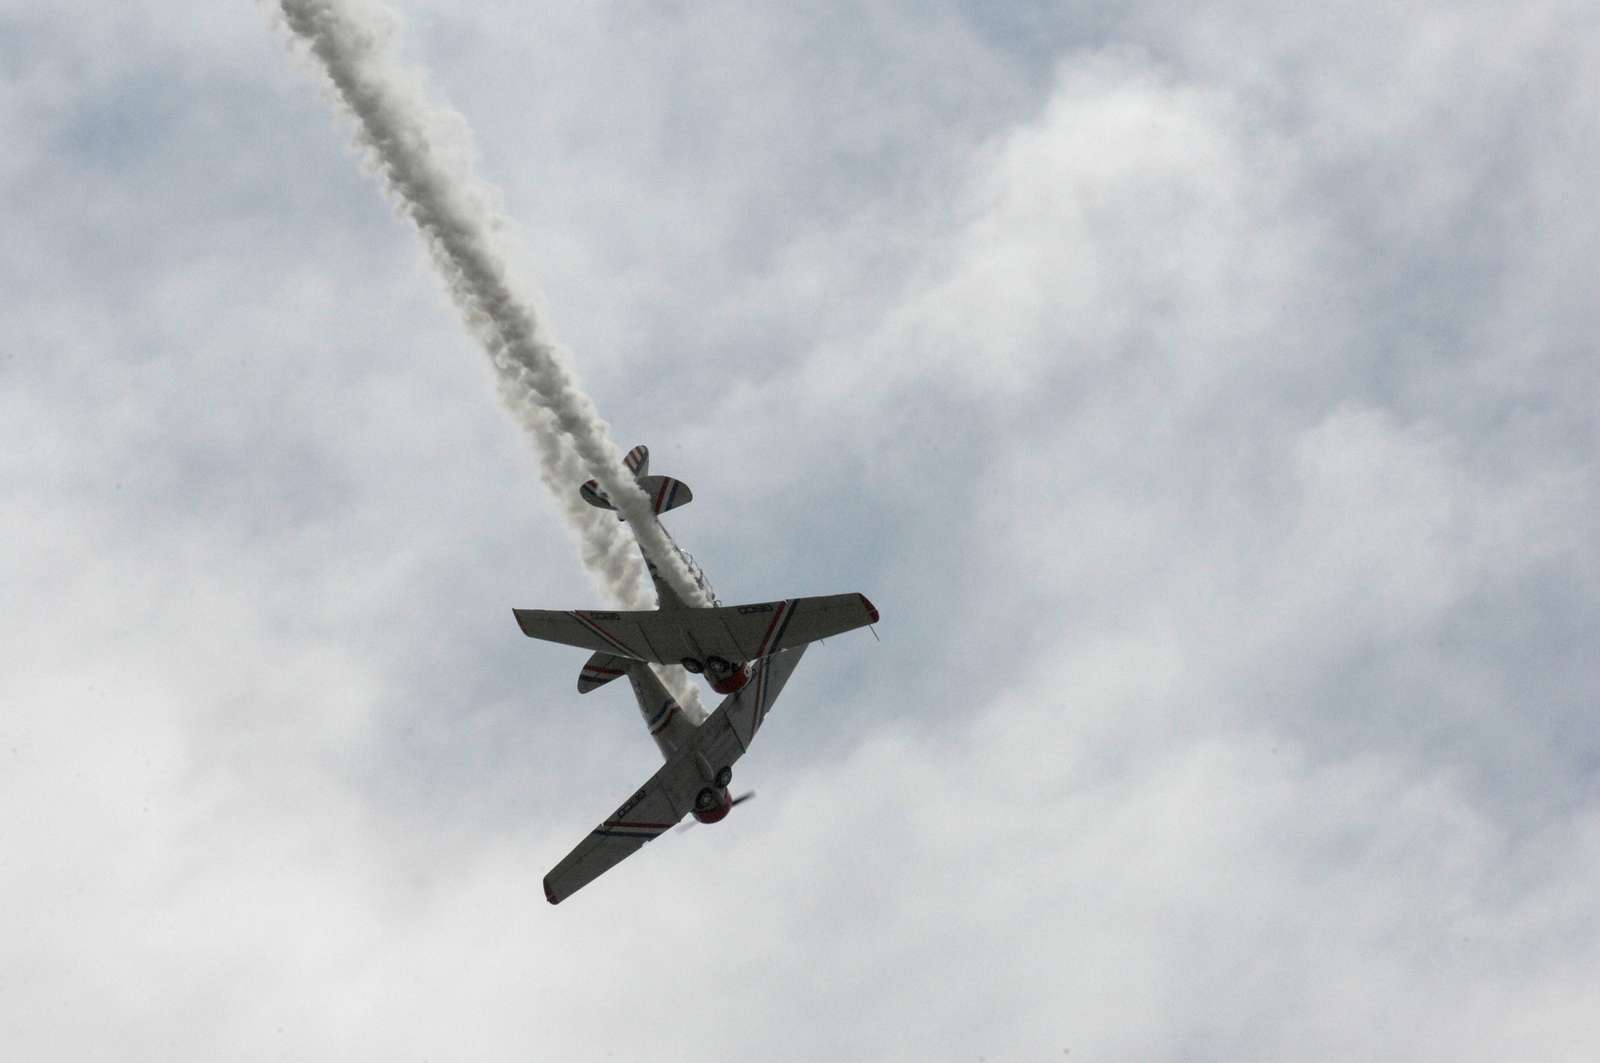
[512,594,878,664]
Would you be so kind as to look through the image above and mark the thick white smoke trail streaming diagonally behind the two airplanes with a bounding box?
[278,0,710,714]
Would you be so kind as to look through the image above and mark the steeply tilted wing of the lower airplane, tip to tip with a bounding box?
[544,647,805,905]
